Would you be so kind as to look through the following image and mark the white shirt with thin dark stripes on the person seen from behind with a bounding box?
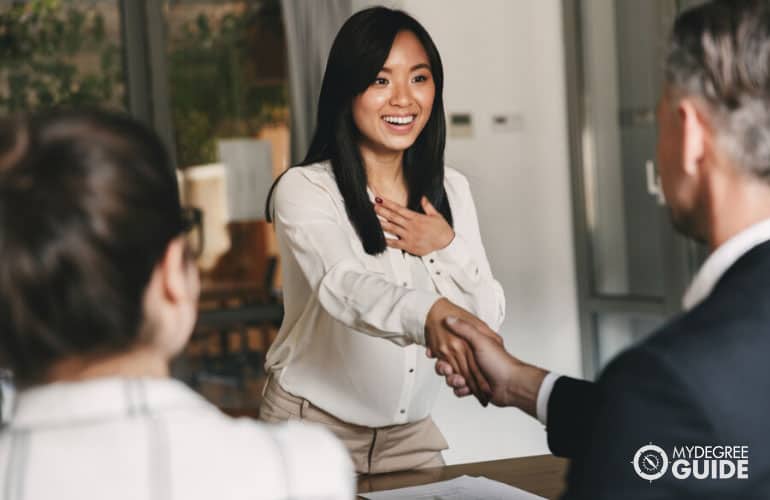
[0,378,353,500]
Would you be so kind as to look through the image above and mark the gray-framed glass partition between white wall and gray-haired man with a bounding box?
[562,0,704,378]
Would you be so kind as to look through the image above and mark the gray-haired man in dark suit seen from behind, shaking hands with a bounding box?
[436,0,770,500]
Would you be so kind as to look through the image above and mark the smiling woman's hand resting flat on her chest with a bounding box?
[374,196,455,257]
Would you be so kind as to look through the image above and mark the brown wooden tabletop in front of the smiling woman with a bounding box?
[358,455,567,498]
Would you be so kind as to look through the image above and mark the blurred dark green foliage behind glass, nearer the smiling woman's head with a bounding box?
[168,0,288,166]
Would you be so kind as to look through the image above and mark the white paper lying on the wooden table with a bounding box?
[359,476,544,500]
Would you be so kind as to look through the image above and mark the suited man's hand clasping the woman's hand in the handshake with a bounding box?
[430,317,548,417]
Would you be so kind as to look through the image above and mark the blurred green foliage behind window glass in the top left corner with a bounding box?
[0,0,125,113]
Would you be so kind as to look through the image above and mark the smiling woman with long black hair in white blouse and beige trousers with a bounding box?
[260,7,505,473]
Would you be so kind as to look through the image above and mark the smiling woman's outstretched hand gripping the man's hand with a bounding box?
[425,298,502,406]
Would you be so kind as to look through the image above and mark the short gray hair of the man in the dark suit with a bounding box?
[665,0,770,181]
